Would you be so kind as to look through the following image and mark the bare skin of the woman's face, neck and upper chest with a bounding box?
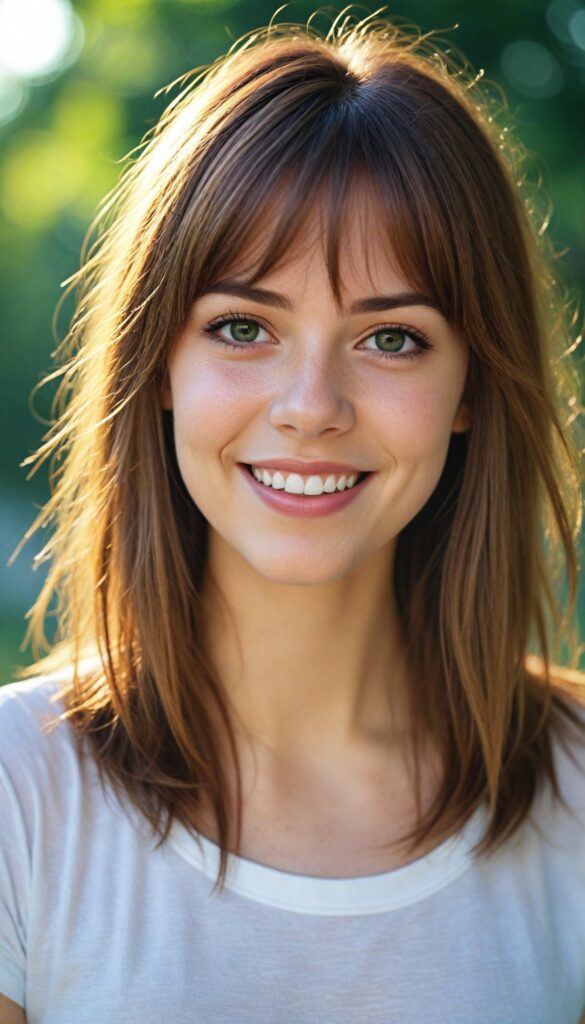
[163,190,469,877]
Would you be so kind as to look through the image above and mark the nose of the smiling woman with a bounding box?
[270,346,354,437]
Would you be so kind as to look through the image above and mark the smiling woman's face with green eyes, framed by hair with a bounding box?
[164,196,468,585]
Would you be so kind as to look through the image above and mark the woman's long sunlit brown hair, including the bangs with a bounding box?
[16,12,585,888]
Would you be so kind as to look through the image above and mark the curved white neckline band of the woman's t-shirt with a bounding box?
[168,805,487,916]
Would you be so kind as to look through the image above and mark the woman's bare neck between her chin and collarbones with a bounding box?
[198,531,409,763]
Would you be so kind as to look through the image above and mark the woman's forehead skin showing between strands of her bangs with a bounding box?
[215,182,421,301]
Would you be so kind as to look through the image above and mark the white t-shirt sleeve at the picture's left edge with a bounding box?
[0,764,30,1007]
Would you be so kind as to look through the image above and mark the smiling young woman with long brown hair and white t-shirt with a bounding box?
[0,9,585,1024]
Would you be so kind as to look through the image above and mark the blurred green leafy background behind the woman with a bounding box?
[0,0,585,682]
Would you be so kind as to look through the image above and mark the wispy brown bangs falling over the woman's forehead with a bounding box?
[179,70,481,327]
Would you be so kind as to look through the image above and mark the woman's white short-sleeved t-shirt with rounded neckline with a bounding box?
[0,678,585,1024]
